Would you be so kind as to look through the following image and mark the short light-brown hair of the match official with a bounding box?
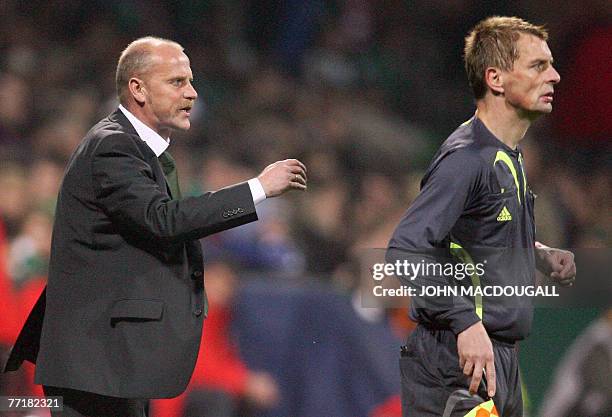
[463,16,548,100]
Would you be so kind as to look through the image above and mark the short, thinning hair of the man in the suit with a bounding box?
[115,36,185,104]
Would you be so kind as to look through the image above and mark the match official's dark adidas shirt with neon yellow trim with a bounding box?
[387,116,535,341]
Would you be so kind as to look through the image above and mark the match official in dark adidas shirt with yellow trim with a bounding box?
[387,17,576,417]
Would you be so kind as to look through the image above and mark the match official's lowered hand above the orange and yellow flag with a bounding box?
[457,321,495,397]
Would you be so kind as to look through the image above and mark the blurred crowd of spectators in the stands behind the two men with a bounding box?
[0,0,612,416]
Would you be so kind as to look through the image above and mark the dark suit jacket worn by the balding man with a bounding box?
[5,110,257,398]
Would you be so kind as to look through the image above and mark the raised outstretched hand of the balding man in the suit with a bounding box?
[257,159,307,197]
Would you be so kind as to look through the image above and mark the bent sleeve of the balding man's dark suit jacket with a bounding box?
[91,134,257,243]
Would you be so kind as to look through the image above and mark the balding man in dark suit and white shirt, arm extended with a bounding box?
[0,37,306,417]
